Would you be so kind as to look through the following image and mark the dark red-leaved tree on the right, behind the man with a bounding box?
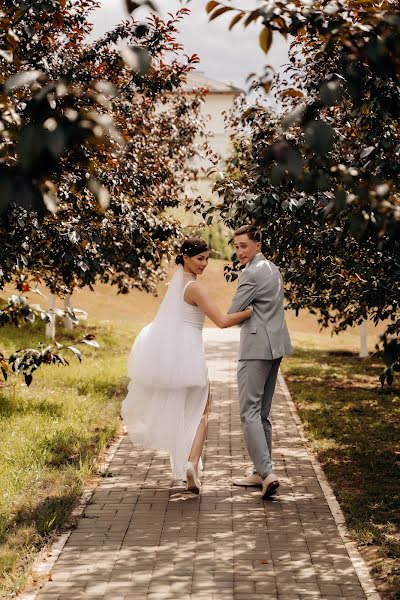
[208,0,400,383]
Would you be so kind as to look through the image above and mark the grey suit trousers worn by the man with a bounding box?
[238,357,282,479]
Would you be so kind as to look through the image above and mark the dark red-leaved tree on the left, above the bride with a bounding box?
[0,0,202,384]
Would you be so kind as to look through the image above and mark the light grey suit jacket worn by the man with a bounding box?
[228,253,292,360]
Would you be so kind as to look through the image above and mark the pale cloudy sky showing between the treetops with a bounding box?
[92,0,287,89]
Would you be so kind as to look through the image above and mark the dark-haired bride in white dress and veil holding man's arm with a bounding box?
[121,237,252,494]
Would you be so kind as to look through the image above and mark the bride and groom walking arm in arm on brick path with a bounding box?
[121,225,291,498]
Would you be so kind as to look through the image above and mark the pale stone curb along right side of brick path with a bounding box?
[278,370,381,600]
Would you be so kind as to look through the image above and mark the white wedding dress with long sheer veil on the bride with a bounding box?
[121,265,209,480]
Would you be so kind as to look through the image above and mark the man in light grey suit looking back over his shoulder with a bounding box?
[228,225,292,498]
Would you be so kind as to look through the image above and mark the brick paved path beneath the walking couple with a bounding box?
[37,330,372,600]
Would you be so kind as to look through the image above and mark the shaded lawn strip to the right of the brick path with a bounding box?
[283,344,400,599]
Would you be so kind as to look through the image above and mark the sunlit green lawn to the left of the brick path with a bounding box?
[0,323,135,597]
